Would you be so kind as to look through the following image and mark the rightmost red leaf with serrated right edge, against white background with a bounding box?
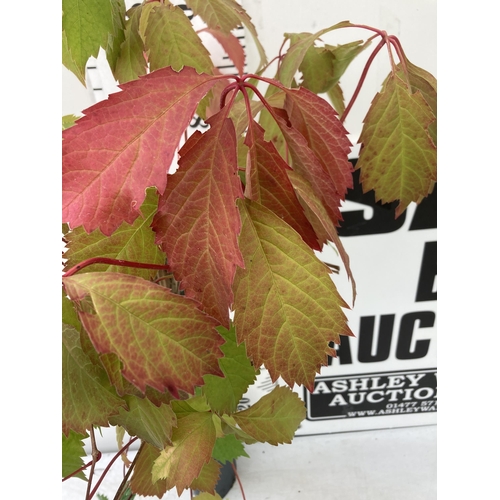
[284,87,354,200]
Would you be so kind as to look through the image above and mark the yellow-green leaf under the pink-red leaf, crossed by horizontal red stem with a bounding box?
[64,189,165,279]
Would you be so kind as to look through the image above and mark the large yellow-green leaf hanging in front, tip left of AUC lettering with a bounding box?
[234,201,352,388]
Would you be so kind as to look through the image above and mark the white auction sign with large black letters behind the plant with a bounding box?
[241,166,437,435]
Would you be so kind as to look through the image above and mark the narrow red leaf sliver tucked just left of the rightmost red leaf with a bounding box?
[275,109,342,226]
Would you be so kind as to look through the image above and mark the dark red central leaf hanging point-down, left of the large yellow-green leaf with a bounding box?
[153,111,243,328]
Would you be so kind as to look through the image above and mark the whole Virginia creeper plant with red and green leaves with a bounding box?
[62,0,437,499]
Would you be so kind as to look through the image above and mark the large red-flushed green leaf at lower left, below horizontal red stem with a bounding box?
[63,273,223,395]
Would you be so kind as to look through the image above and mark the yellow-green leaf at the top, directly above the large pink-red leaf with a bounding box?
[141,2,214,73]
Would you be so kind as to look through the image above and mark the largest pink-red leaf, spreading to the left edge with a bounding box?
[62,67,217,236]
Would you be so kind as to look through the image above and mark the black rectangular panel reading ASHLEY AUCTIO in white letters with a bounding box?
[304,368,437,420]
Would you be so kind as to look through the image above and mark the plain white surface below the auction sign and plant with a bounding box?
[62,425,437,500]
